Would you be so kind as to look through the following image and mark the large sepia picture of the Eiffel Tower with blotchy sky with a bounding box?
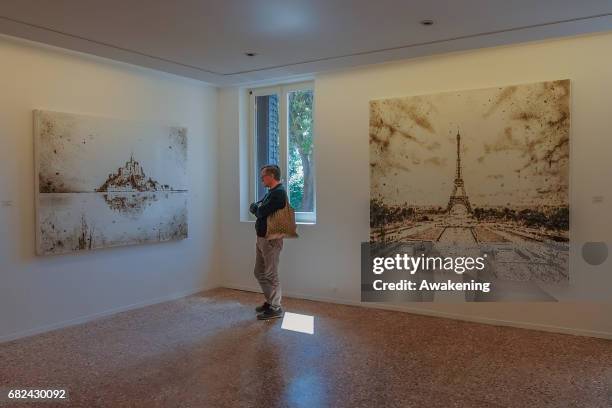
[369,80,570,283]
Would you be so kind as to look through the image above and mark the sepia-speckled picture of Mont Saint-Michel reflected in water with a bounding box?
[34,110,188,255]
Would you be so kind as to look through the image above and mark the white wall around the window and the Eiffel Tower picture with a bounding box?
[219,33,612,338]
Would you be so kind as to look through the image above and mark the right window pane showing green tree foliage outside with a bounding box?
[287,90,314,212]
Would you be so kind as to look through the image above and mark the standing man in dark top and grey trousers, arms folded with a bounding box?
[249,164,287,320]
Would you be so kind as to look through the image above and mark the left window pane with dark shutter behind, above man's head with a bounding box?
[255,94,280,200]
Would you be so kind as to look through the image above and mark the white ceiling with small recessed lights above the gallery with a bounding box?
[0,0,612,85]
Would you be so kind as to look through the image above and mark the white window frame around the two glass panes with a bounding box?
[248,81,317,224]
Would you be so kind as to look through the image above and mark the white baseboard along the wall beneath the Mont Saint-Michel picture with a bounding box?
[0,285,219,343]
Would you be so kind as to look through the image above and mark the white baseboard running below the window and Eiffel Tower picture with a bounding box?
[221,283,612,340]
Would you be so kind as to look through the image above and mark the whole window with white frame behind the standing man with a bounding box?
[249,82,316,223]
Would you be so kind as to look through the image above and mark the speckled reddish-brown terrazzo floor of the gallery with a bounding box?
[0,289,612,408]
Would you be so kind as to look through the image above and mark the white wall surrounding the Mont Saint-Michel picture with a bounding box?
[0,37,220,341]
